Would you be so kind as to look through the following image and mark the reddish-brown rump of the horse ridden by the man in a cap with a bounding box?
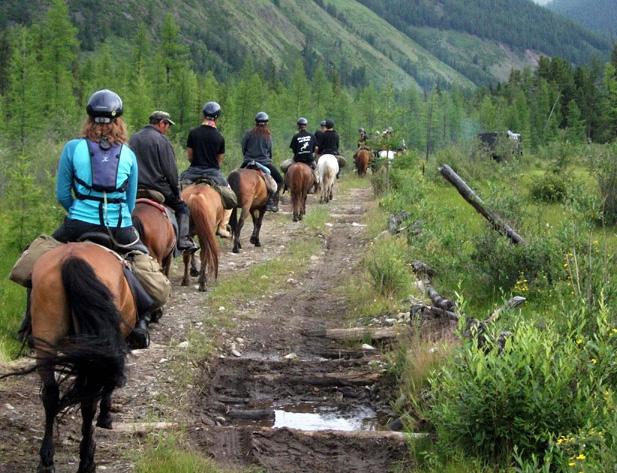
[131,199,176,276]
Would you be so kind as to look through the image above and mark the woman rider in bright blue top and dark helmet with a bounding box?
[19,89,148,339]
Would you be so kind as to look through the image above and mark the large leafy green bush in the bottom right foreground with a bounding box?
[428,302,617,460]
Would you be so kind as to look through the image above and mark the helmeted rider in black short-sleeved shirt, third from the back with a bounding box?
[180,102,233,238]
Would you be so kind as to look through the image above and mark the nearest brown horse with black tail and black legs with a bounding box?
[3,243,137,473]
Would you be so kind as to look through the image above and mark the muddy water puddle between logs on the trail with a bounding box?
[272,405,379,432]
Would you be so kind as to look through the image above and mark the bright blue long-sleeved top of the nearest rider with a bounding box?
[56,138,138,227]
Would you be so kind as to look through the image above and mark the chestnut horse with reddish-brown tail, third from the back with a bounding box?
[182,184,223,292]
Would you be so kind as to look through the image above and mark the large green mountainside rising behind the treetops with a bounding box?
[0,0,610,89]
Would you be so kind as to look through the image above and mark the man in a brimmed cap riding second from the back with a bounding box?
[129,111,199,252]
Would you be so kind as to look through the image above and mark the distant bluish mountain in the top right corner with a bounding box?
[547,0,617,38]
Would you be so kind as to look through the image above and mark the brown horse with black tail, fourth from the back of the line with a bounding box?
[227,169,268,253]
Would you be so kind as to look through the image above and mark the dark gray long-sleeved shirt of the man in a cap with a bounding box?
[129,125,180,197]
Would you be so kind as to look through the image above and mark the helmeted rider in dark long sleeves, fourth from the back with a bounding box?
[240,112,284,212]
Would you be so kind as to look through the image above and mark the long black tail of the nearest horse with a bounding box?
[53,257,128,411]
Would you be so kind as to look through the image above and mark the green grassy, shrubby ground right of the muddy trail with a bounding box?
[357,142,617,472]
